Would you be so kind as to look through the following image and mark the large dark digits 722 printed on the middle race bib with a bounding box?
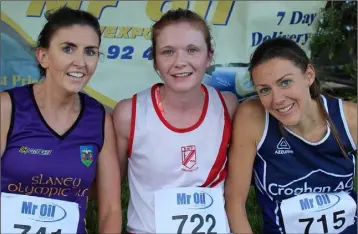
[172,214,217,234]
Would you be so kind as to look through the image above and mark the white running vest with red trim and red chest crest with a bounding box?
[127,84,231,233]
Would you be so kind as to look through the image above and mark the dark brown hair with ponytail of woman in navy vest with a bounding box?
[249,38,347,157]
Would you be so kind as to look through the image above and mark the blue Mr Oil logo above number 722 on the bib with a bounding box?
[177,191,214,209]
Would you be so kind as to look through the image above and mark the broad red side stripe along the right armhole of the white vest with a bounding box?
[201,90,231,187]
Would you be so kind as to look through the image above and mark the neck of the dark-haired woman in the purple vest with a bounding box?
[36,78,78,113]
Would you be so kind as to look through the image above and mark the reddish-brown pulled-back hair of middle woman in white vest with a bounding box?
[151,8,213,66]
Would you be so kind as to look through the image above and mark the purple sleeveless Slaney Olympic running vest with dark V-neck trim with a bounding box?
[1,84,105,233]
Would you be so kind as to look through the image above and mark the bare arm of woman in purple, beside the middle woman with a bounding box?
[96,113,122,233]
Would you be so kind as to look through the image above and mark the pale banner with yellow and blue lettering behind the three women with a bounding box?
[0,0,326,109]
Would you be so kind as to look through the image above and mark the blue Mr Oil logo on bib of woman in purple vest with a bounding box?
[21,201,67,222]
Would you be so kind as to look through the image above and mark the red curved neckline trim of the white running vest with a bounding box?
[151,83,209,133]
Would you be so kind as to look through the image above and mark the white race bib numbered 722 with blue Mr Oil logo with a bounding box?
[155,187,228,233]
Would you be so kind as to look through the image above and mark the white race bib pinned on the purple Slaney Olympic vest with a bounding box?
[1,193,79,234]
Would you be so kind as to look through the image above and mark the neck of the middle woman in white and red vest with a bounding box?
[160,85,205,112]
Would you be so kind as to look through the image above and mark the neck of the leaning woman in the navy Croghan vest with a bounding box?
[287,99,326,136]
